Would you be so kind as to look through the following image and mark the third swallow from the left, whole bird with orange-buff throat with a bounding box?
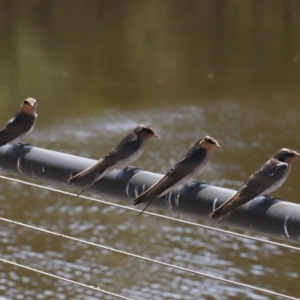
[133,135,220,216]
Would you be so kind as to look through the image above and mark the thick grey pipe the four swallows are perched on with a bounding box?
[0,145,300,243]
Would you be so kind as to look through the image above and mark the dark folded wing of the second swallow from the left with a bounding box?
[68,134,141,183]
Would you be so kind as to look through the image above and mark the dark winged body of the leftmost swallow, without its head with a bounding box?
[0,111,35,147]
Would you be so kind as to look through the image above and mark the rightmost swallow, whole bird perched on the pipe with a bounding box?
[208,148,300,226]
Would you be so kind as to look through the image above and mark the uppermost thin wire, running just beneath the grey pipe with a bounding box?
[0,175,300,251]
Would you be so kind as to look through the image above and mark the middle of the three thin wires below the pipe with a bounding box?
[0,217,299,300]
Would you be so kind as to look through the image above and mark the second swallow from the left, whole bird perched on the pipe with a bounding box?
[68,124,157,197]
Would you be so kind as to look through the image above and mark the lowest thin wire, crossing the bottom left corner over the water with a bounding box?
[0,258,133,300]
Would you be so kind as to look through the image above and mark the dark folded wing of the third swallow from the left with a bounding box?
[133,143,206,205]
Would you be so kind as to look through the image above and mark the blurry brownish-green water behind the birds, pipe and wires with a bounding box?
[0,0,300,300]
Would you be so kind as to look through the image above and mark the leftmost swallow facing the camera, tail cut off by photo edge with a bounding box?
[0,98,37,147]
